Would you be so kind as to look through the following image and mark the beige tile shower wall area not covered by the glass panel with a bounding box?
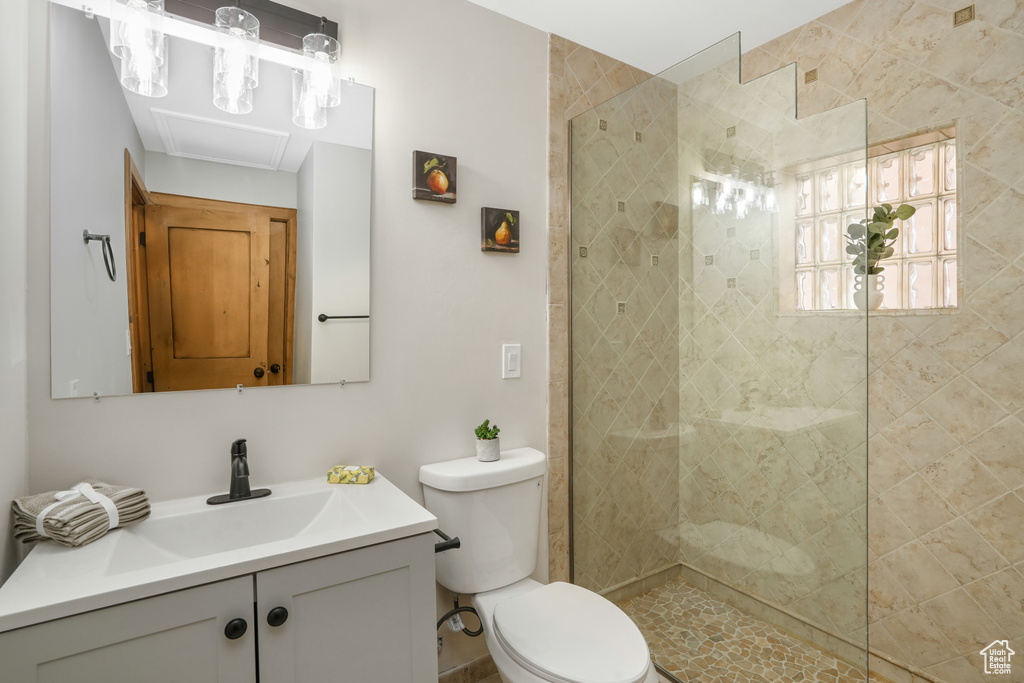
[743,0,1024,683]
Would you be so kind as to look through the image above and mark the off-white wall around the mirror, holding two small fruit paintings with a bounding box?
[18,0,547,669]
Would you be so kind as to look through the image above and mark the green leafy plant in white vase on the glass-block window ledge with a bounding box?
[846,204,916,310]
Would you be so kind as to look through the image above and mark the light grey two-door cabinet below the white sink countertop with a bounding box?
[0,533,437,683]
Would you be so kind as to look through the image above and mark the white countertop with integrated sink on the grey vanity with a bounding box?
[0,473,437,633]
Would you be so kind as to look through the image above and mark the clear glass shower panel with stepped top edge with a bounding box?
[570,35,867,683]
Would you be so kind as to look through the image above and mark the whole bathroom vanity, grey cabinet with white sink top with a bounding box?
[0,474,437,683]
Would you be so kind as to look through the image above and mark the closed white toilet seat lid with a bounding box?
[494,582,650,683]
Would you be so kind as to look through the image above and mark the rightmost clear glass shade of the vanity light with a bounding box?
[292,28,341,129]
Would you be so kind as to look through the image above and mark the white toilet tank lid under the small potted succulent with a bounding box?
[420,449,547,492]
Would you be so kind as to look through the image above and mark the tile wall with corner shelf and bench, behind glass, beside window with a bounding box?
[678,55,867,643]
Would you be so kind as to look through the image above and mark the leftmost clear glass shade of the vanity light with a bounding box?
[111,0,167,97]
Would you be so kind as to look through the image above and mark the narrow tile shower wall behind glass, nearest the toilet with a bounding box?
[569,61,679,590]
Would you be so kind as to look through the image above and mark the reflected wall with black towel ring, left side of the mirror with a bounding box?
[48,6,144,397]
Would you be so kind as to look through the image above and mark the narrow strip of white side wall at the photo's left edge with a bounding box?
[0,0,29,583]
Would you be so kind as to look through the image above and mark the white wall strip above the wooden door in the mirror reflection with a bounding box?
[143,152,296,209]
